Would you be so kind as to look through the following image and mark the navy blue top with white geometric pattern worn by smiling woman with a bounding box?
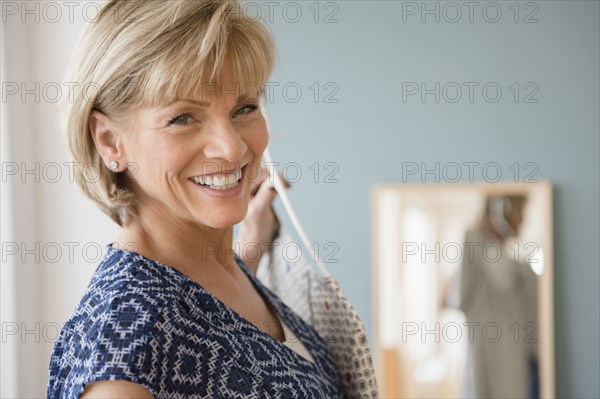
[48,245,342,399]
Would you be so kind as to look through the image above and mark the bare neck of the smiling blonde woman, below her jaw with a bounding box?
[115,205,237,275]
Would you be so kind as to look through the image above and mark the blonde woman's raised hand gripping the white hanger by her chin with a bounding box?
[234,166,289,273]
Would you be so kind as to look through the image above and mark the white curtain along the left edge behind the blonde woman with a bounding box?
[0,1,116,398]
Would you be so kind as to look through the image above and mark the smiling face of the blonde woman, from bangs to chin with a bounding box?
[117,63,268,228]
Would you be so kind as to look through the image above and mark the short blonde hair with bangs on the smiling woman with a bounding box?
[61,0,276,226]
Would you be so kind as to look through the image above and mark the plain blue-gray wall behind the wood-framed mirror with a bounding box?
[263,1,600,398]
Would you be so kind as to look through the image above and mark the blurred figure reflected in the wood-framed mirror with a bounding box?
[458,194,539,398]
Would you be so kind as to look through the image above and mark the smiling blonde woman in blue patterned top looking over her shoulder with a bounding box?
[48,0,341,398]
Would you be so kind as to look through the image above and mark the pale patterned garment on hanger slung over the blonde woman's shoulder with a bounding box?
[257,231,378,399]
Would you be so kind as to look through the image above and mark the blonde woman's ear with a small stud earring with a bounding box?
[88,111,126,172]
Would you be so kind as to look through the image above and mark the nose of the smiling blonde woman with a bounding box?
[204,120,248,162]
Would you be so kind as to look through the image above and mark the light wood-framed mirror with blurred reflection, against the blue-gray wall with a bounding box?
[373,183,554,398]
